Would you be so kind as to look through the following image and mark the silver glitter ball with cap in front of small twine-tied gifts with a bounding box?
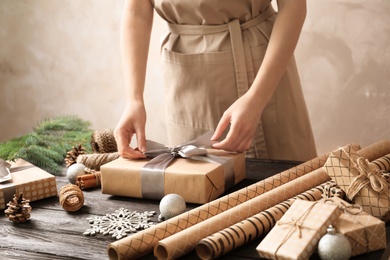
[318,225,352,260]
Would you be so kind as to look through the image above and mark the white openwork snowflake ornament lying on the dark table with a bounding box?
[83,208,156,239]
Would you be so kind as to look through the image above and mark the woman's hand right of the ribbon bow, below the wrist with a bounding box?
[211,93,262,152]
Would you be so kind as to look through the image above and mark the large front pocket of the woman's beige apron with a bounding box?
[162,49,237,129]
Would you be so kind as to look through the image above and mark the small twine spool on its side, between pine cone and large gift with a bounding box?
[60,184,84,212]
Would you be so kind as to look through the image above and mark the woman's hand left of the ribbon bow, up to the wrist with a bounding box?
[114,102,146,159]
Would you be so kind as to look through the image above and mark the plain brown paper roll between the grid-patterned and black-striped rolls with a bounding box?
[154,168,330,259]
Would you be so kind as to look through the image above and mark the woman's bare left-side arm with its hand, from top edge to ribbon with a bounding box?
[114,0,153,159]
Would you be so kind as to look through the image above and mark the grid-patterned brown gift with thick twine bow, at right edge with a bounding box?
[323,146,390,219]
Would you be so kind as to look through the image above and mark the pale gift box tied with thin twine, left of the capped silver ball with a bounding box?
[256,200,340,259]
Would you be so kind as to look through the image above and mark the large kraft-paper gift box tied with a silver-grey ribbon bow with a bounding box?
[100,133,246,204]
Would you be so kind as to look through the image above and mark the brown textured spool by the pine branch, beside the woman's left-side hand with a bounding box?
[91,129,118,153]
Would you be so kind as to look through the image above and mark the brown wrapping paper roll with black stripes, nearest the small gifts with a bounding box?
[196,181,344,259]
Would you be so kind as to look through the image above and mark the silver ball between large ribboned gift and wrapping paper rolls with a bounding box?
[159,193,186,220]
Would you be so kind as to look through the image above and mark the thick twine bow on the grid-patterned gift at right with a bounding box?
[346,157,389,200]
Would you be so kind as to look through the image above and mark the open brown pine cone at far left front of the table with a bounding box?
[4,194,32,223]
